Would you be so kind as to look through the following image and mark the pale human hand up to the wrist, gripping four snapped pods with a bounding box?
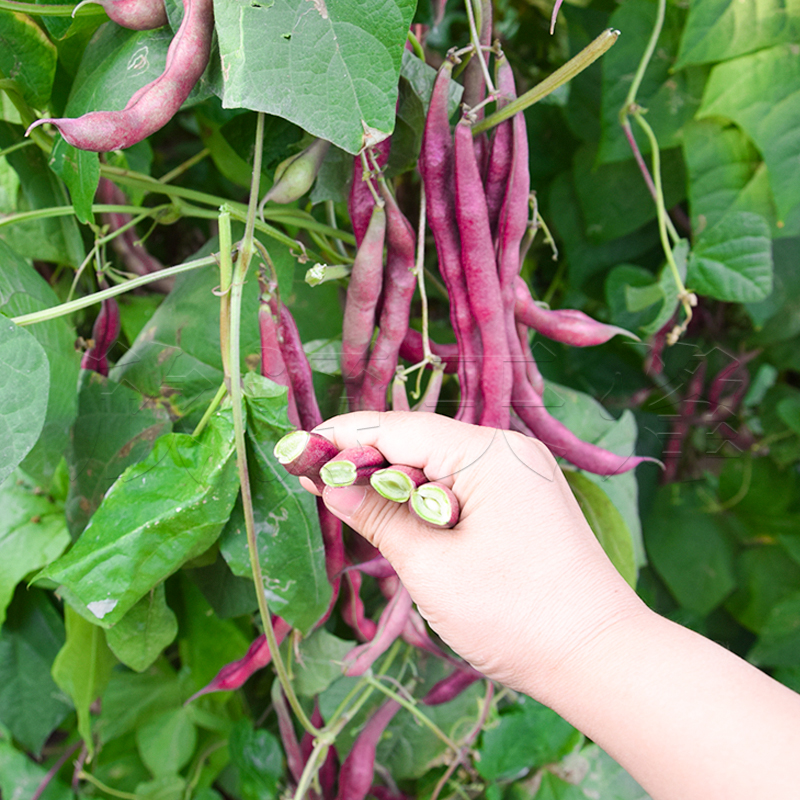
[304,412,644,696]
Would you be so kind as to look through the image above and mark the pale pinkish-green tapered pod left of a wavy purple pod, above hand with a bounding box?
[342,204,386,411]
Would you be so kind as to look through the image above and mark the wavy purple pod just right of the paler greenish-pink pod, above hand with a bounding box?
[357,181,417,411]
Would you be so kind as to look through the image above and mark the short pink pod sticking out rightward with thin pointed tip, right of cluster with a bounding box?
[514,278,639,347]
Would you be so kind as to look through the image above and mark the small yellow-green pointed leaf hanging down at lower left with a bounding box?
[53,606,116,757]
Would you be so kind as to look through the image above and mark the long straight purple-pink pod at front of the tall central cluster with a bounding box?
[455,118,511,429]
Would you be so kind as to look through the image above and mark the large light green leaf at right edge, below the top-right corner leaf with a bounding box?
[698,45,800,220]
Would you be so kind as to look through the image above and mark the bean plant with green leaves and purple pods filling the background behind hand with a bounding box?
[0,0,800,800]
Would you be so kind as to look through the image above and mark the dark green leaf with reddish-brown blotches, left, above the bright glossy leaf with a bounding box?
[66,371,171,536]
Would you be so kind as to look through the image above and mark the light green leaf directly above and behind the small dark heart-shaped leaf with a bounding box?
[683,119,790,236]
